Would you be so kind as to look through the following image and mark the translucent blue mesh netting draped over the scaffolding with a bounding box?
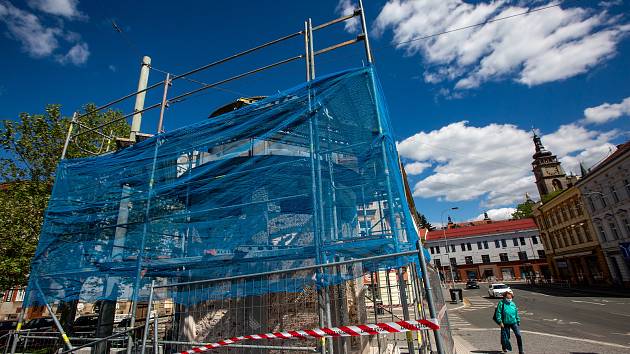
[29,67,428,304]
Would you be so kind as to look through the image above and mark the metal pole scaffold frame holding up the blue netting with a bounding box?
[7,0,454,354]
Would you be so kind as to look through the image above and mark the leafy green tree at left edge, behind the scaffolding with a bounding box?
[0,104,129,289]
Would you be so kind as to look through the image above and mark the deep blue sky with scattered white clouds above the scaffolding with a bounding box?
[0,0,630,224]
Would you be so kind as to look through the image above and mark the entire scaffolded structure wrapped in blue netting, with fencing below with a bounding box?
[0,3,453,354]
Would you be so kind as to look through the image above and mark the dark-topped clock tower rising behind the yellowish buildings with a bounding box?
[532,133,575,199]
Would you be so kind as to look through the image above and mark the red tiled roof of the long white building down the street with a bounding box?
[427,218,538,240]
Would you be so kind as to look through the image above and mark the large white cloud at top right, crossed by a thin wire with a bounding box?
[375,0,630,89]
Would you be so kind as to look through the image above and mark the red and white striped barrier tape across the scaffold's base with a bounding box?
[180,320,440,354]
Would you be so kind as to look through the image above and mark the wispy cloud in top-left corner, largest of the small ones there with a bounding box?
[0,1,62,58]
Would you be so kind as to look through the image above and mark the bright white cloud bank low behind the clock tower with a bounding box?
[398,121,616,208]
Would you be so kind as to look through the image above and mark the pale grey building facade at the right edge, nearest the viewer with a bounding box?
[577,142,630,286]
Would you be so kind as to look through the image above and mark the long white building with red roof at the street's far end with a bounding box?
[424,218,551,281]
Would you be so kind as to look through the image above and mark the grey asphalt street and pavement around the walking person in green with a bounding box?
[449,284,630,353]
